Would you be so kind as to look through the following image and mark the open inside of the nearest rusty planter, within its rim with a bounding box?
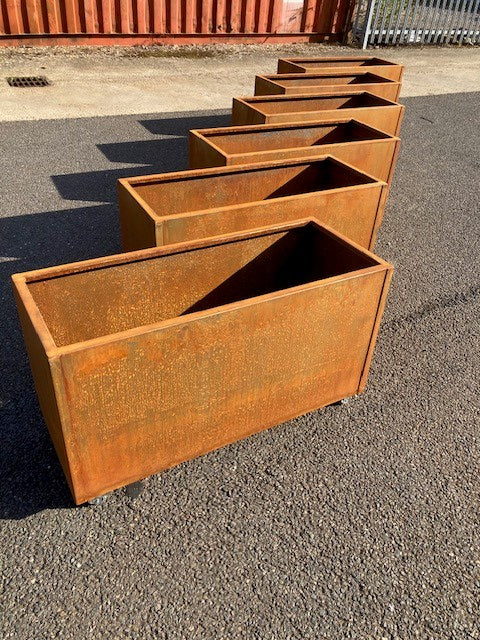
[27,223,377,348]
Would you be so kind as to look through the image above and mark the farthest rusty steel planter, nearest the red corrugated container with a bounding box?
[278,56,403,82]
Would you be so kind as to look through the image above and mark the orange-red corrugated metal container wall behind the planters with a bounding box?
[0,0,350,45]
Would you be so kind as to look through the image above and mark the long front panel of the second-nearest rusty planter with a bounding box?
[163,185,382,249]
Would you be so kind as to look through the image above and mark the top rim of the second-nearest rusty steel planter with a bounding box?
[118,154,387,221]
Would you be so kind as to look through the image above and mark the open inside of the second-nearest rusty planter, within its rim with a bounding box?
[131,157,375,218]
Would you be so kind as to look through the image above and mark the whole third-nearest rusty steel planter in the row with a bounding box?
[189,120,400,184]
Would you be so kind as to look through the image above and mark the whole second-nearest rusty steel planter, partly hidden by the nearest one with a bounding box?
[118,156,388,251]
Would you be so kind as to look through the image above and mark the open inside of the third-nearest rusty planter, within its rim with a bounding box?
[199,120,391,155]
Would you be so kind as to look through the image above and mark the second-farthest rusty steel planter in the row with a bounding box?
[255,71,402,101]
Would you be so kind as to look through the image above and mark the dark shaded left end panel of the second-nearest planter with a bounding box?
[117,182,162,251]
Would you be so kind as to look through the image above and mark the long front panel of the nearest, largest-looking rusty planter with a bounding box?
[57,270,385,502]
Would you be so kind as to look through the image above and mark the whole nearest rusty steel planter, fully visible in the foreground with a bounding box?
[13,222,392,504]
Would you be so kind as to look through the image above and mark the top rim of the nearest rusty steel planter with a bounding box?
[12,218,393,358]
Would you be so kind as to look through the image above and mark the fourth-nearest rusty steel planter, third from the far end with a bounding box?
[232,91,404,136]
